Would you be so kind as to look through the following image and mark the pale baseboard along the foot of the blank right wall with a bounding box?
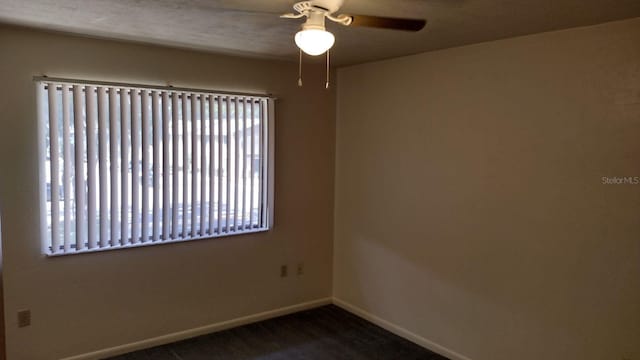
[333,297,471,360]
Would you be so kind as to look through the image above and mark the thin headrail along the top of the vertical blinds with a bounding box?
[33,76,278,100]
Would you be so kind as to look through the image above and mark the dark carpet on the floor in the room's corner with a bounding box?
[105,305,447,360]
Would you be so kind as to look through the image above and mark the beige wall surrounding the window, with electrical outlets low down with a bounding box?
[0,27,335,360]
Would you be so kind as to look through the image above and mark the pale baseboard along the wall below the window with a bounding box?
[62,298,332,360]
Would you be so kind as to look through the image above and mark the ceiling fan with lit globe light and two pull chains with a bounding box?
[280,0,427,89]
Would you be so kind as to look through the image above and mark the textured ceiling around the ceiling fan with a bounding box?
[0,0,640,65]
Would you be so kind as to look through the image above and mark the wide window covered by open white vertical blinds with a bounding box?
[37,78,273,255]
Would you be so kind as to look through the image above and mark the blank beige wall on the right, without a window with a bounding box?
[334,19,640,360]
